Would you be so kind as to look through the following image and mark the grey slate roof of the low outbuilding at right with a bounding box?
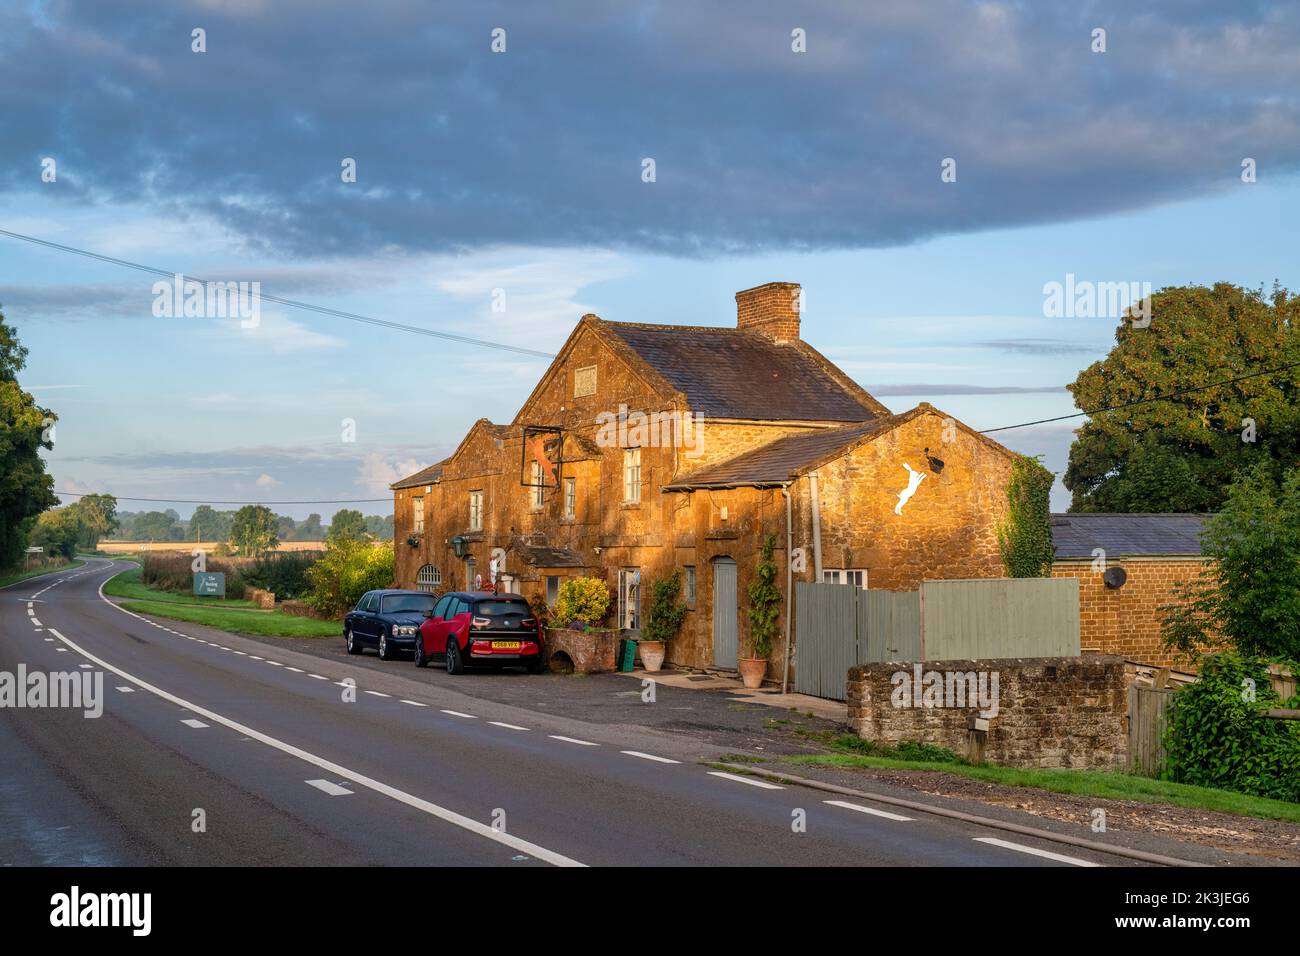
[1052,511,1212,559]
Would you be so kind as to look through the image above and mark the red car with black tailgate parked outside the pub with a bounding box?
[415,591,542,674]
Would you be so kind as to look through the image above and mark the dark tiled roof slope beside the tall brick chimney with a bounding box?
[592,316,889,421]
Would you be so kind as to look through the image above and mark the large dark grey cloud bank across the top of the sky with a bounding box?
[0,0,1300,255]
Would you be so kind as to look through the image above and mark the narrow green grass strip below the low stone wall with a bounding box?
[785,753,1300,823]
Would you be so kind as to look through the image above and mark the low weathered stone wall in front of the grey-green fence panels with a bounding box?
[848,654,1128,769]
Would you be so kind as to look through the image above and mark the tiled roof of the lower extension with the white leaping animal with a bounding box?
[664,402,1015,492]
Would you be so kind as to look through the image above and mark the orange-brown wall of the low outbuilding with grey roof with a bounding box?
[1052,558,1209,670]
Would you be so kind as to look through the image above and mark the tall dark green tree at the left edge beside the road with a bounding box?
[0,312,59,568]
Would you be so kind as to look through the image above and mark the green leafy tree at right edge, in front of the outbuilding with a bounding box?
[1161,460,1300,662]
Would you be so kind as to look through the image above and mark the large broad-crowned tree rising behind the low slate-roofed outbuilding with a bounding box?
[1065,282,1300,511]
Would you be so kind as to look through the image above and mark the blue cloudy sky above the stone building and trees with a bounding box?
[0,0,1300,518]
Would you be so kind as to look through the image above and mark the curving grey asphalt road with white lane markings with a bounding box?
[0,559,1125,866]
